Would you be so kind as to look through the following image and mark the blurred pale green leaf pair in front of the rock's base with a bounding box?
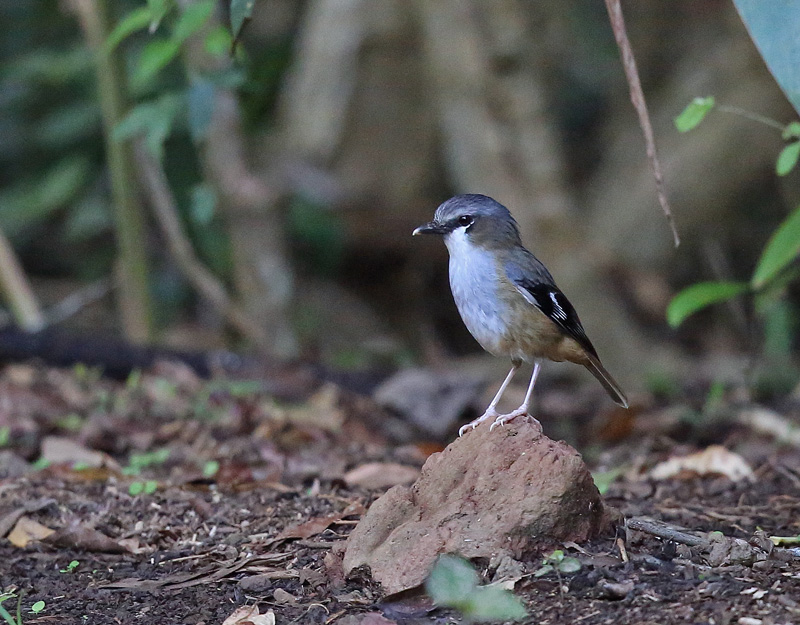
[425,554,527,623]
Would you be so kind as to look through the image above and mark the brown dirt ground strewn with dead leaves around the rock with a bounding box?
[0,365,800,625]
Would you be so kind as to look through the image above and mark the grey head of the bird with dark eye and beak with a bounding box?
[414,193,521,249]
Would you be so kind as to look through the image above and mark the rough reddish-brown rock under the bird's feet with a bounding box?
[343,419,608,593]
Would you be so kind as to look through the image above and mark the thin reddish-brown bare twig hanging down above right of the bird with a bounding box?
[606,0,681,247]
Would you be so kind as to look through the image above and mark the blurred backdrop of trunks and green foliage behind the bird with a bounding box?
[0,0,800,388]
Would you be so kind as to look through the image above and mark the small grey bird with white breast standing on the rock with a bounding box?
[413,194,628,436]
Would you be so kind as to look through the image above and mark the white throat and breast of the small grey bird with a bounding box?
[444,228,506,354]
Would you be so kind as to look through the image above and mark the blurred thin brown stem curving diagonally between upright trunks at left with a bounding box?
[134,140,266,347]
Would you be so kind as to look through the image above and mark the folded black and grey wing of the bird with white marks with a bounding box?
[505,250,597,358]
